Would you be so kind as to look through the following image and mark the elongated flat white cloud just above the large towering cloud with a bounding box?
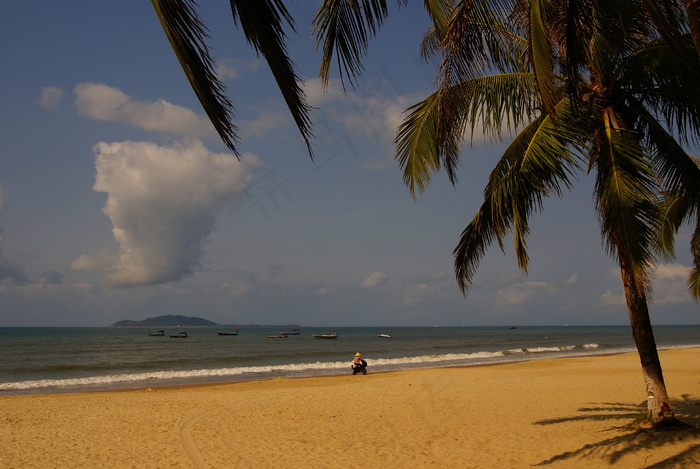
[75,83,217,139]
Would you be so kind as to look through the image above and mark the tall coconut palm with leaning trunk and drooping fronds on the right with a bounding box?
[396,0,700,425]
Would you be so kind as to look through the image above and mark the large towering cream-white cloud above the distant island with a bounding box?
[71,137,254,287]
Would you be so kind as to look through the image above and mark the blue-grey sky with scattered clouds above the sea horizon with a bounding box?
[0,0,700,327]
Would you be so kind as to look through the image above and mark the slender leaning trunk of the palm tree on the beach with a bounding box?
[620,255,676,426]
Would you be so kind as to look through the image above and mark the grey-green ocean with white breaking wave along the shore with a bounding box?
[0,325,700,395]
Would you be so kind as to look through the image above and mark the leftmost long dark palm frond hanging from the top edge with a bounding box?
[151,0,238,155]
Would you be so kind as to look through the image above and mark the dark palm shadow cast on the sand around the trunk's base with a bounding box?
[534,395,700,469]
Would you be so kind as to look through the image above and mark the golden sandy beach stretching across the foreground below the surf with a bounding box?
[0,349,700,469]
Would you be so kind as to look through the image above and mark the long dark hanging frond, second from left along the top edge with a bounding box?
[230,0,313,157]
